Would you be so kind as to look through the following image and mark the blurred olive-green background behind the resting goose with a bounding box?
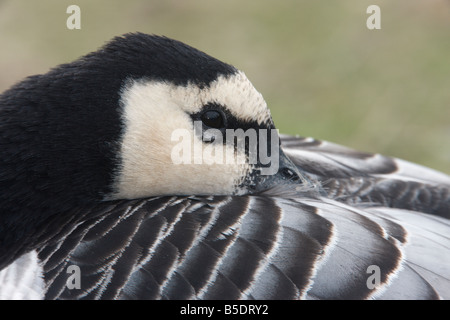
[0,0,450,173]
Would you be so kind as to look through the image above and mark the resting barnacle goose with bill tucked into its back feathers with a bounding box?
[0,33,450,299]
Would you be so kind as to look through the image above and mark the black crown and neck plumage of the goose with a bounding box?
[0,33,236,268]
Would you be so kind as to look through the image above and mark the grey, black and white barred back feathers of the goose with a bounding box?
[39,136,450,299]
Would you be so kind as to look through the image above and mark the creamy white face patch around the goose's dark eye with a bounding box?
[108,73,270,199]
